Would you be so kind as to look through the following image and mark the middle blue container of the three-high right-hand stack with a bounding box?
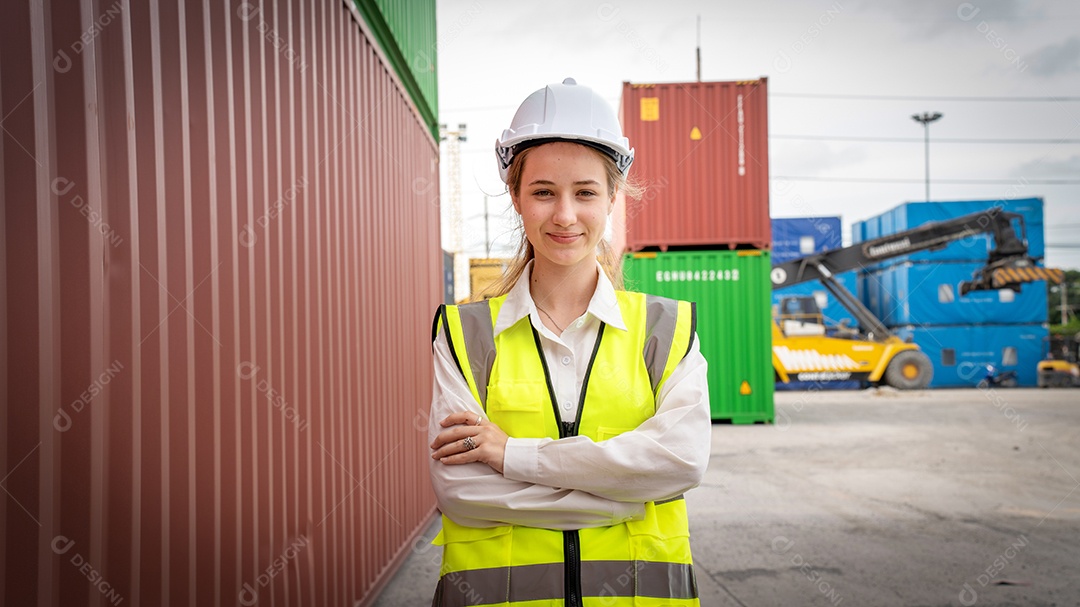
[865,264,1047,326]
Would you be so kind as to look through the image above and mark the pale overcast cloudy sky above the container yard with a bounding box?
[437,0,1080,268]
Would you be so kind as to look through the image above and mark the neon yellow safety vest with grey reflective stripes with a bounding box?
[432,292,699,607]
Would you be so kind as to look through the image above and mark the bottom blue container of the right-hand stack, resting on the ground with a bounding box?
[895,324,1050,388]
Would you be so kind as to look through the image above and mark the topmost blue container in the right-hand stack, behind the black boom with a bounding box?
[851,198,1047,269]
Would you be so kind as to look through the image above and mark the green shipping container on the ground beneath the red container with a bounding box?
[623,249,773,423]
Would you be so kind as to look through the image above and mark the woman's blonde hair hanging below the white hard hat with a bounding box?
[481,141,645,300]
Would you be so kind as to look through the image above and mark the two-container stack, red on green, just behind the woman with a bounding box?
[613,78,773,423]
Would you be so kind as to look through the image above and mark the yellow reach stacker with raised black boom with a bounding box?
[771,207,1064,390]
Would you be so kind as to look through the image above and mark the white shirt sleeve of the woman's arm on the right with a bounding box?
[503,338,712,502]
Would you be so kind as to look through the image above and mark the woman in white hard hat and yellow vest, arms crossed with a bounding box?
[430,79,711,606]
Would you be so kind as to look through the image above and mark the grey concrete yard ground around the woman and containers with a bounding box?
[375,389,1080,607]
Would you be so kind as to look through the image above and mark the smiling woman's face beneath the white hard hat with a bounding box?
[511,141,615,268]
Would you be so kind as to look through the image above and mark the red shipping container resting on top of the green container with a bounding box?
[620,78,770,251]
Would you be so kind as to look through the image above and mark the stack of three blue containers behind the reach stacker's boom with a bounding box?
[852,199,1048,388]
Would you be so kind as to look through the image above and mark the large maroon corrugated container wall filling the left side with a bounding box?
[0,0,442,606]
